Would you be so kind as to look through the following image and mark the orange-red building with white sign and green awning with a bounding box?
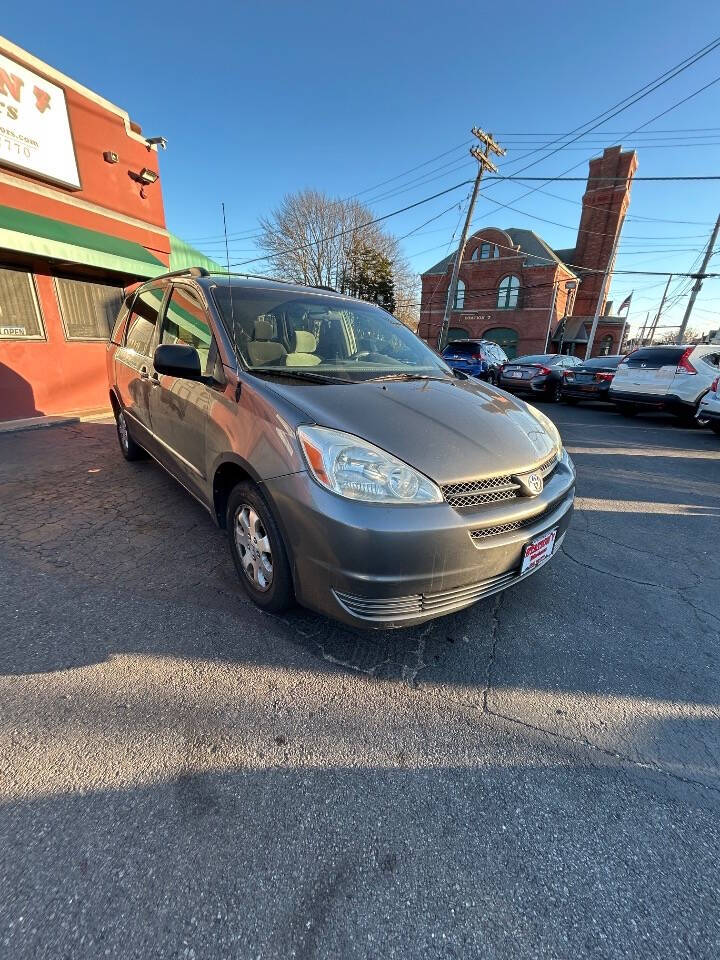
[0,37,214,421]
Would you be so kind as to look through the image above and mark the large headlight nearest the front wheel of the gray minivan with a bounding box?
[297,427,443,503]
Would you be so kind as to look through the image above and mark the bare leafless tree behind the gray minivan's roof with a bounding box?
[258,190,418,328]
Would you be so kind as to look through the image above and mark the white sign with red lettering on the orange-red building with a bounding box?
[0,53,80,190]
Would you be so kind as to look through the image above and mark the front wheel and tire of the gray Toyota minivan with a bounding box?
[227,482,295,613]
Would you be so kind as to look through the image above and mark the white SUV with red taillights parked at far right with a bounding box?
[609,344,720,421]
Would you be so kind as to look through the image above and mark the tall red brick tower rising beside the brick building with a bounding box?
[572,146,637,317]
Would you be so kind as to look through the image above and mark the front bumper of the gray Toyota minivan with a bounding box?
[264,453,575,629]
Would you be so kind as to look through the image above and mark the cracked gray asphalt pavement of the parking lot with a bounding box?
[0,406,720,960]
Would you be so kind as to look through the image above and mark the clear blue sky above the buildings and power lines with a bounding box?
[2,0,720,329]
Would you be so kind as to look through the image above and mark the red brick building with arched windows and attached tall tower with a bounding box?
[418,146,637,357]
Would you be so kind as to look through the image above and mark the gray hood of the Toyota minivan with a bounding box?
[258,380,554,484]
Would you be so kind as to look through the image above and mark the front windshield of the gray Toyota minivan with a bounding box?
[213,284,453,383]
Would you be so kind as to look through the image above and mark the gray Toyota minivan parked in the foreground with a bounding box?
[107,268,575,627]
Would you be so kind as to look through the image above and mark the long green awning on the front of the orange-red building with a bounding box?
[0,205,168,278]
